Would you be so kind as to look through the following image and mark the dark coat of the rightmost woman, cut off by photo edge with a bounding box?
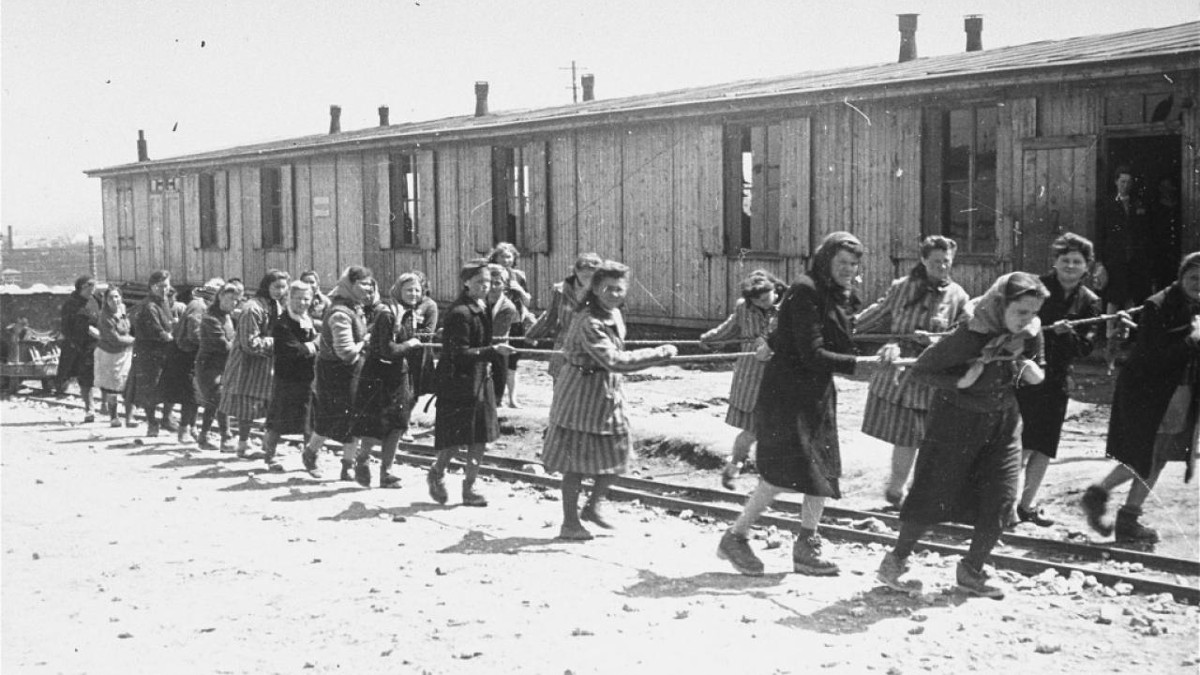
[1105,282,1200,478]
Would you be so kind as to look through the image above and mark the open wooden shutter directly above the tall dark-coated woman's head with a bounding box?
[779,118,812,257]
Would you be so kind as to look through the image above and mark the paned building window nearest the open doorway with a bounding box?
[941,107,998,253]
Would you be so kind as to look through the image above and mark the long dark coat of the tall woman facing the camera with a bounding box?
[755,270,854,497]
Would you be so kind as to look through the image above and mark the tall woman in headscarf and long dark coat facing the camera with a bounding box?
[716,232,878,577]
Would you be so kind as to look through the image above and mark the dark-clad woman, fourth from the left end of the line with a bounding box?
[158,279,224,444]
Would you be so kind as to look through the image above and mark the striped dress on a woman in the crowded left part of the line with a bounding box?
[218,297,275,419]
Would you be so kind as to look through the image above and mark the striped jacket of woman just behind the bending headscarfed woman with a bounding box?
[854,276,971,410]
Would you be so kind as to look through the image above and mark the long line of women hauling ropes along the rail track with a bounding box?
[51,232,1200,597]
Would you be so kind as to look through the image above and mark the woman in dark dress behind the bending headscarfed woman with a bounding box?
[1013,232,1100,527]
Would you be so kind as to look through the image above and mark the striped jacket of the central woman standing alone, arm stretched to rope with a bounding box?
[550,310,668,436]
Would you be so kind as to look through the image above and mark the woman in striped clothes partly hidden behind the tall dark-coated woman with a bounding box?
[700,269,787,490]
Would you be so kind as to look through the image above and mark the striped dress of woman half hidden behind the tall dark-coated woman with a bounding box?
[700,299,779,431]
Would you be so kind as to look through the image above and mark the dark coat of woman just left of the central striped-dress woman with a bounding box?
[433,294,504,448]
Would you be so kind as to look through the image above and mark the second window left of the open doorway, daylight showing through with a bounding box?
[724,124,782,252]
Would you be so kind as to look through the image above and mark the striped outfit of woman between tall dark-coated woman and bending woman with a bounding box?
[854,276,970,448]
